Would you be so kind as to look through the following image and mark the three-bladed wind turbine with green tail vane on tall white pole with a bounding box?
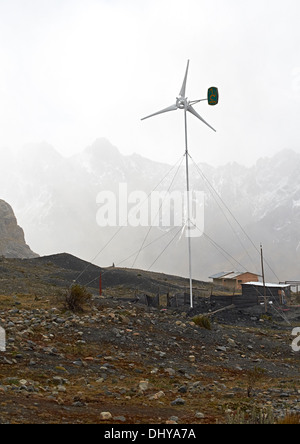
[141,60,219,308]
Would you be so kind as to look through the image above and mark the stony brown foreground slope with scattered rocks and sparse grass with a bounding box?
[0,253,300,424]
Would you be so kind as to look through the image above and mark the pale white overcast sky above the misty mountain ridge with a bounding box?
[0,0,300,165]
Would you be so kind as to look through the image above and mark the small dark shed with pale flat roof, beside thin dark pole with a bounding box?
[242,282,291,305]
